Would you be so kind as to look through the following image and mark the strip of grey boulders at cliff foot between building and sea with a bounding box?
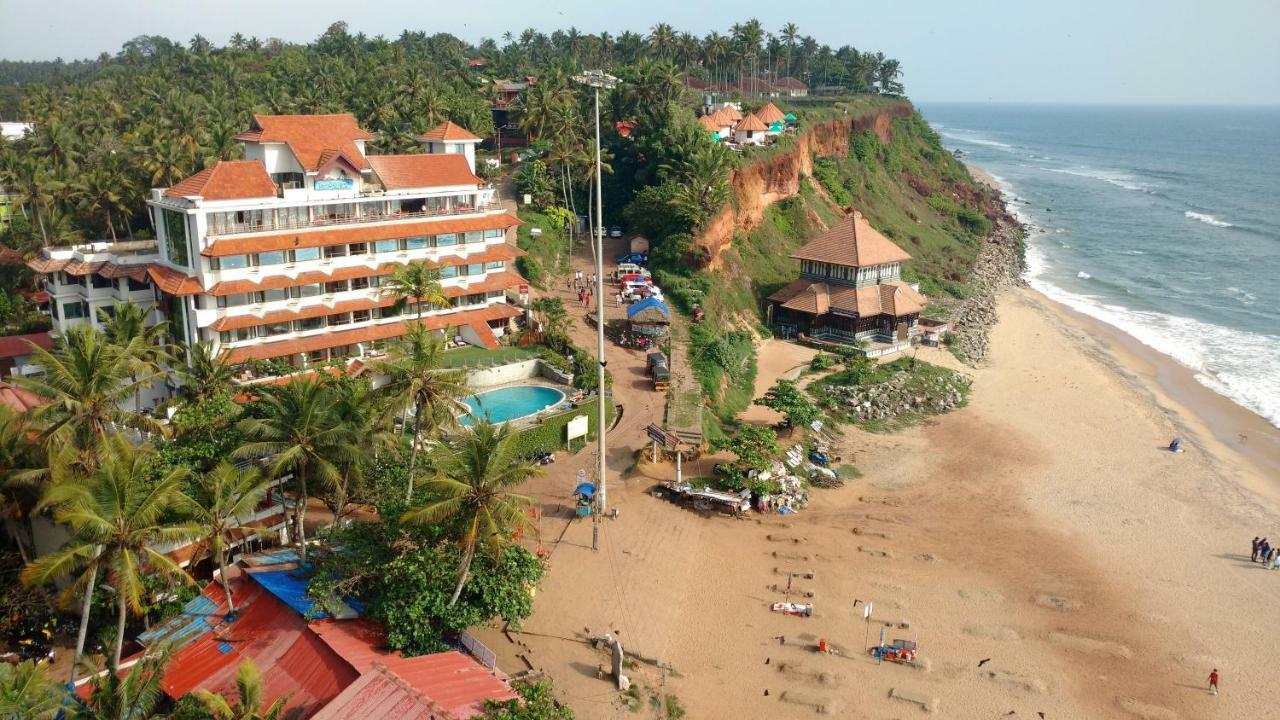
[951,214,1027,365]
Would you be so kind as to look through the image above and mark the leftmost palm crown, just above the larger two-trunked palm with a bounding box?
[13,325,161,455]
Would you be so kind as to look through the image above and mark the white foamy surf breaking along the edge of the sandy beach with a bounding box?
[1027,238,1280,427]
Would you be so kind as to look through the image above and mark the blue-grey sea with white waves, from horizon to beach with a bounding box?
[920,104,1280,427]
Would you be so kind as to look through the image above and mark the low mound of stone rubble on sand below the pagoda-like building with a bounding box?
[826,370,973,420]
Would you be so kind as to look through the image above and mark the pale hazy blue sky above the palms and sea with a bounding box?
[0,0,1280,104]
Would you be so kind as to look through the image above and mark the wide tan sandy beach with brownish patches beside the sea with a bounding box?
[479,275,1280,720]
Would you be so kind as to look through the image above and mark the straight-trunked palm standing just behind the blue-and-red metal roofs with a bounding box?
[232,377,360,562]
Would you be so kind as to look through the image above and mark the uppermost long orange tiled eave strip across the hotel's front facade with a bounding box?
[201,213,521,258]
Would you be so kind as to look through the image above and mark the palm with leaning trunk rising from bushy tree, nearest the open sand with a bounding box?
[401,423,541,607]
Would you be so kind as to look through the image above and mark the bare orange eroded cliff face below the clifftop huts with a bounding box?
[694,102,913,269]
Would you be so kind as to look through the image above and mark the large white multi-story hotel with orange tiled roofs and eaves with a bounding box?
[29,114,525,392]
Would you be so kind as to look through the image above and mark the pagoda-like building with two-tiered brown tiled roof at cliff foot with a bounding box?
[767,210,927,355]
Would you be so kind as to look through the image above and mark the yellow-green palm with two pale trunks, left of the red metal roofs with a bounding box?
[22,436,198,674]
